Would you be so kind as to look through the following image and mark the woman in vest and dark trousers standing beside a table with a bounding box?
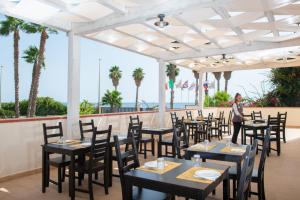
[231,93,244,144]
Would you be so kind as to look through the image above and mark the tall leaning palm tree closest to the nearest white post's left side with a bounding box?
[24,24,57,117]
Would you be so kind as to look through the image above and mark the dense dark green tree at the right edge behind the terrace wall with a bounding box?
[270,67,300,107]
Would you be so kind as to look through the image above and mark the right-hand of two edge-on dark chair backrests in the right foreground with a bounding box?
[258,128,270,179]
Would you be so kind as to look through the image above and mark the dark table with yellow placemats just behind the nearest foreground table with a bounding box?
[185,142,247,196]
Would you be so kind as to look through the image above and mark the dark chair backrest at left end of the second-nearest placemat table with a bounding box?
[173,122,189,158]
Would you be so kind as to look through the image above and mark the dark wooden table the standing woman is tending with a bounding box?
[241,120,269,144]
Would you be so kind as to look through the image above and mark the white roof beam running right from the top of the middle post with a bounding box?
[165,38,300,61]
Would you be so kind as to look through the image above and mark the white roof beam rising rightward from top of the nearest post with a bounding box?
[73,0,216,34]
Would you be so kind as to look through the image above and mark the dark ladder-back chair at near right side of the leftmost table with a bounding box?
[75,125,112,200]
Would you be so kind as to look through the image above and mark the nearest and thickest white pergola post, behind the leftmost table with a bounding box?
[67,31,80,138]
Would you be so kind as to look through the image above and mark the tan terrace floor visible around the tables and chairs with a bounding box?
[0,129,300,200]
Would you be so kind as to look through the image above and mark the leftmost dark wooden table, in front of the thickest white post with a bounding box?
[42,136,125,199]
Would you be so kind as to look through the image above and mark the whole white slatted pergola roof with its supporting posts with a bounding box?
[0,0,300,134]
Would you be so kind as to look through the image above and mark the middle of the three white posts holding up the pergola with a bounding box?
[158,60,166,127]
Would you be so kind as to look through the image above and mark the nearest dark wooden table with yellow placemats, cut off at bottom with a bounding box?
[124,158,230,200]
